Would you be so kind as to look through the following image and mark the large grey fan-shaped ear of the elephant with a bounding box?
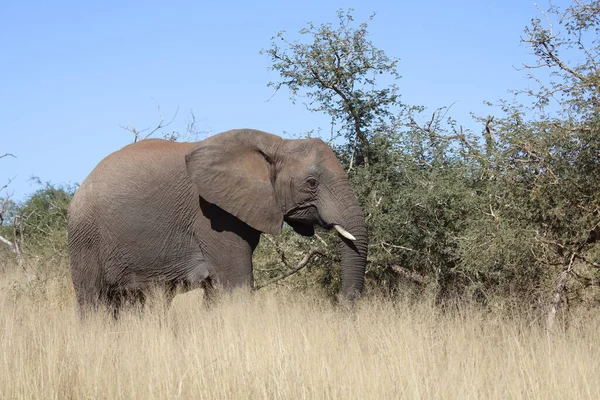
[185,129,283,234]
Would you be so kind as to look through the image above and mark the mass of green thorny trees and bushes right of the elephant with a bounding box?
[263,1,600,316]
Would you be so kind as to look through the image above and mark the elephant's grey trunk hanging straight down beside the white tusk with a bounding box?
[339,204,368,301]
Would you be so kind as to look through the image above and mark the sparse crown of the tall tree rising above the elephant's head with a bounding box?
[261,9,399,166]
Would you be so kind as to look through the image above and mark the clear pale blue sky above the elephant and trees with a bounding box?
[0,0,569,199]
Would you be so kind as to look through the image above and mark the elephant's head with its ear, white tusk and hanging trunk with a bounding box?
[186,129,367,299]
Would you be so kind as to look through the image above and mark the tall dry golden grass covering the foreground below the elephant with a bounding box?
[0,266,600,399]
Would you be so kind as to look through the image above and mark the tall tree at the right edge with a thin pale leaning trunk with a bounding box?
[511,0,600,329]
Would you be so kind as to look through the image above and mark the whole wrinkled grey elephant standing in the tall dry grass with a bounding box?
[68,129,367,316]
